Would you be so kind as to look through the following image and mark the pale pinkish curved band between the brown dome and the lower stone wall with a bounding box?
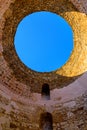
[0,72,87,111]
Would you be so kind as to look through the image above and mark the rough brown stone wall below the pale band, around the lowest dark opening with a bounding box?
[0,85,87,130]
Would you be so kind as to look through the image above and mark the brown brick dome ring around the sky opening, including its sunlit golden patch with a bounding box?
[1,0,87,92]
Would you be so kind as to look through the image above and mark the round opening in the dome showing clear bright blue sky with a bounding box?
[14,11,73,72]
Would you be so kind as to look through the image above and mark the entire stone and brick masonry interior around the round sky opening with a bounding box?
[0,0,87,130]
